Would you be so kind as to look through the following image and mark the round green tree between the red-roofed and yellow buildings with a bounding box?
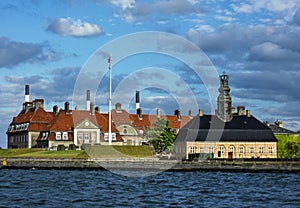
[146,118,175,153]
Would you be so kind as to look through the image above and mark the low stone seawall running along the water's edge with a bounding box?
[1,158,300,173]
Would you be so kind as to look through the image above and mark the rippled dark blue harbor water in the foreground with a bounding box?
[0,169,300,208]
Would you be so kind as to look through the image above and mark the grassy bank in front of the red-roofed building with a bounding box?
[0,146,152,158]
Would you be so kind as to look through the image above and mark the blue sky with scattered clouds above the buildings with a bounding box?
[0,0,300,148]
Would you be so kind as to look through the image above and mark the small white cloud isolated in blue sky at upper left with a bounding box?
[47,17,102,37]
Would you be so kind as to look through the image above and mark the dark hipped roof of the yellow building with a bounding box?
[176,115,277,142]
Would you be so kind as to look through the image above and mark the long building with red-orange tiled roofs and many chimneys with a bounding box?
[6,85,192,148]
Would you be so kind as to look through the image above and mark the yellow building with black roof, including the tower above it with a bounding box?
[175,73,278,159]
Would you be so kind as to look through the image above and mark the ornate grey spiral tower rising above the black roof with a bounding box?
[216,72,232,122]
